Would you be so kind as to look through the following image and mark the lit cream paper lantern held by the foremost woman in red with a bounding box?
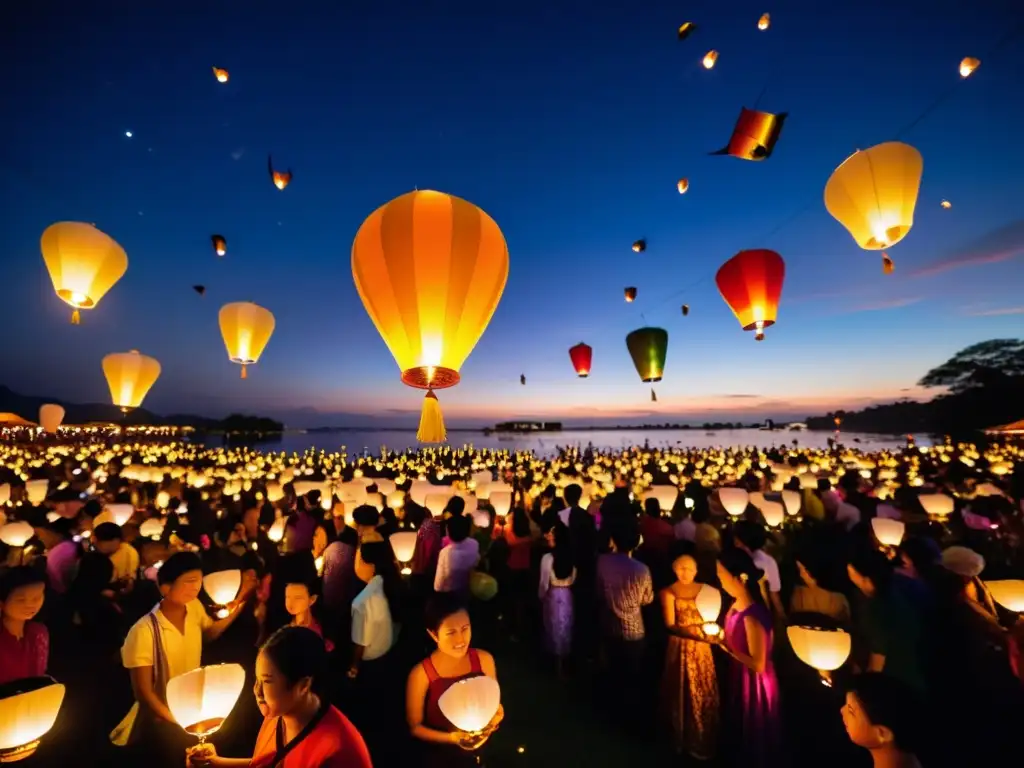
[167,664,246,742]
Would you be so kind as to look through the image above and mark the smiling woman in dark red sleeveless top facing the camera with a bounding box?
[406,593,505,768]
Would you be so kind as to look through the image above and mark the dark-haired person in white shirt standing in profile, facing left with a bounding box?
[348,542,397,678]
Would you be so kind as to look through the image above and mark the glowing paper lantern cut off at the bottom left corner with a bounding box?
[0,677,65,763]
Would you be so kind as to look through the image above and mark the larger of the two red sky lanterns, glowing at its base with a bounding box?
[715,249,785,341]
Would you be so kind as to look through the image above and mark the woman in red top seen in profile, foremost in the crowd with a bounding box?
[186,627,373,768]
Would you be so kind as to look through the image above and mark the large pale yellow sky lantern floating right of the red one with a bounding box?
[824,141,925,251]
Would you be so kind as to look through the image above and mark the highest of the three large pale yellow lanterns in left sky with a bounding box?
[40,221,128,325]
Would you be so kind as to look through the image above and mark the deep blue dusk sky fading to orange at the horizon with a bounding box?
[0,0,1024,426]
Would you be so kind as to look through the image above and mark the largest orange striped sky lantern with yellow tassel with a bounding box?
[352,189,509,442]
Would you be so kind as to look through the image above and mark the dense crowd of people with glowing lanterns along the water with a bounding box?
[0,440,1024,768]
